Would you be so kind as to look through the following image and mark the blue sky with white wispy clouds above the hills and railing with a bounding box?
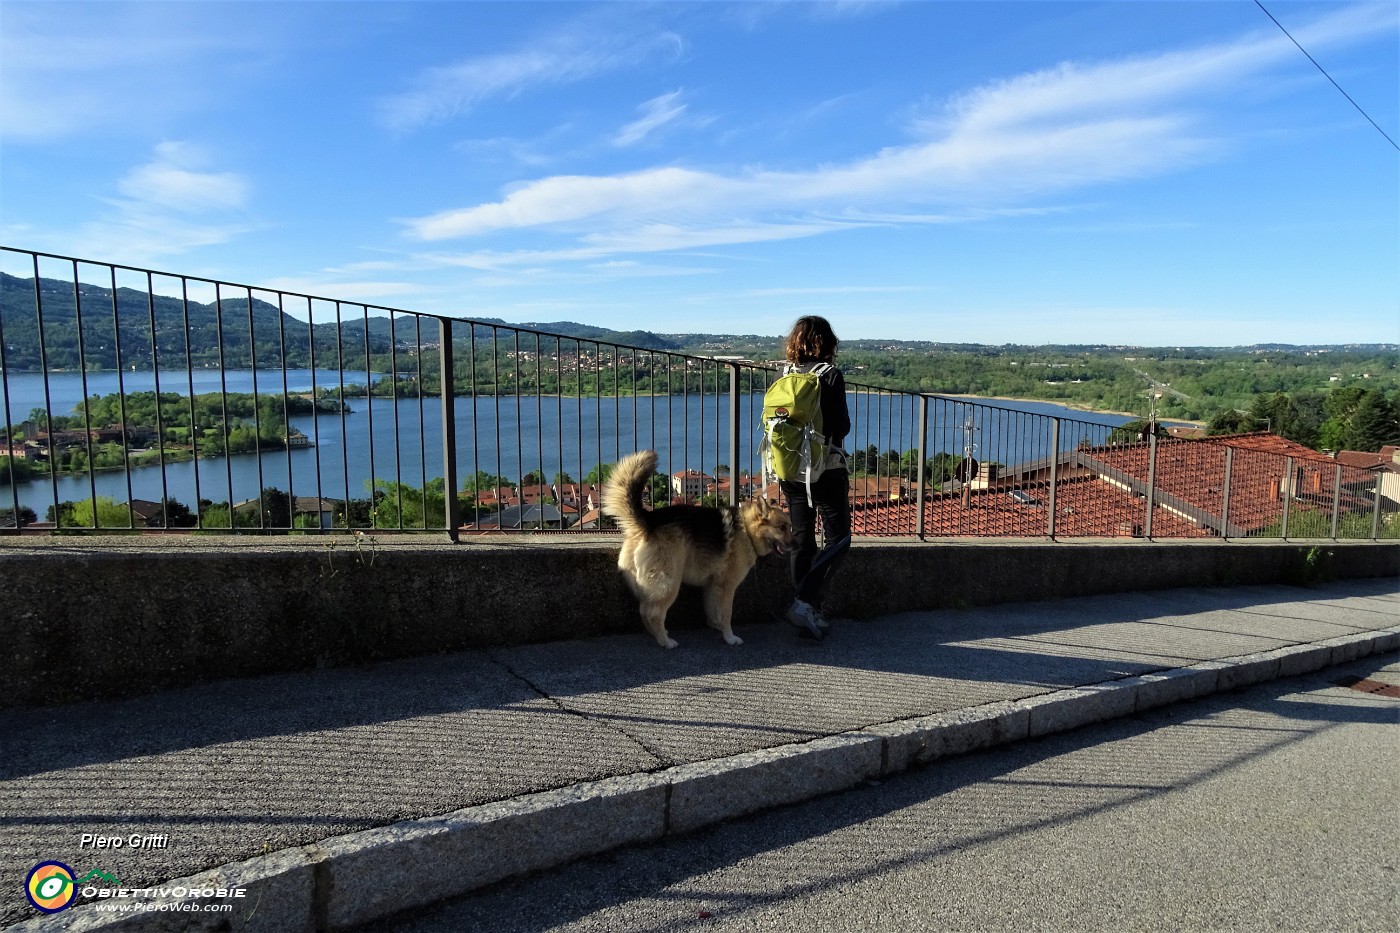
[0,0,1400,346]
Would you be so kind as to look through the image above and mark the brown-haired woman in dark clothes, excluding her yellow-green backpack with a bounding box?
[778,315,851,640]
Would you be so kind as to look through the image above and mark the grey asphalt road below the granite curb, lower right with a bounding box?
[365,654,1400,933]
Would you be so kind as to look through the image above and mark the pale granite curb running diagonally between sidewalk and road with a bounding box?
[8,626,1400,932]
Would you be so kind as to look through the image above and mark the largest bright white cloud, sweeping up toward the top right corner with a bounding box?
[405,6,1396,268]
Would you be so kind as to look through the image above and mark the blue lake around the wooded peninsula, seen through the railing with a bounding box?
[0,370,1130,520]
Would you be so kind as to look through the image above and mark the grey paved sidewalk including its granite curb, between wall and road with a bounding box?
[0,577,1400,930]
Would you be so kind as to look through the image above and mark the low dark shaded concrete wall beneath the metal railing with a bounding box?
[0,535,1400,707]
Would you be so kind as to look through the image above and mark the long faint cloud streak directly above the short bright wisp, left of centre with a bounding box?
[378,20,682,132]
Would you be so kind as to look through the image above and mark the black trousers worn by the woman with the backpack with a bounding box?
[778,468,851,608]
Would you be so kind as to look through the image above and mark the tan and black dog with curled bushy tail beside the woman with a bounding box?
[603,450,792,649]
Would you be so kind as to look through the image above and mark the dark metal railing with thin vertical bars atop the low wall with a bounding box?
[0,248,1400,539]
